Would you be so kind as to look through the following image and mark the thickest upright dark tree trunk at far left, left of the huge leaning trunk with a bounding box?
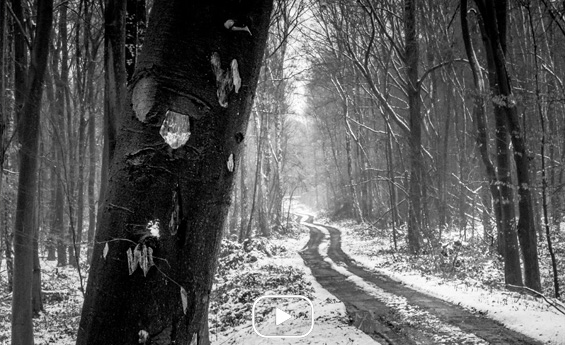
[12,0,53,345]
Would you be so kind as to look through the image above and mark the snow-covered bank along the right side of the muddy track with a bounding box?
[328,218,565,344]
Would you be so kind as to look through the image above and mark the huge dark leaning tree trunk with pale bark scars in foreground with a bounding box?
[77,0,272,344]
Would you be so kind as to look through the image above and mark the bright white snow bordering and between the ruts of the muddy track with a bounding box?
[221,200,565,345]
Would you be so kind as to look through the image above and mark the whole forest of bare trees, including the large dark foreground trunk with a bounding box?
[0,0,565,345]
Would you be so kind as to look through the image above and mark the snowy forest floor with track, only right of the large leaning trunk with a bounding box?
[211,206,565,345]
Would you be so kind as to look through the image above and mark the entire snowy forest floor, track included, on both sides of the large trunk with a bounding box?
[0,206,565,345]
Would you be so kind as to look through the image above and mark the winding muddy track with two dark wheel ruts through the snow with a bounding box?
[300,218,542,345]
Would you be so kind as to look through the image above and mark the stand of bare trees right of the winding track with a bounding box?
[288,1,565,294]
